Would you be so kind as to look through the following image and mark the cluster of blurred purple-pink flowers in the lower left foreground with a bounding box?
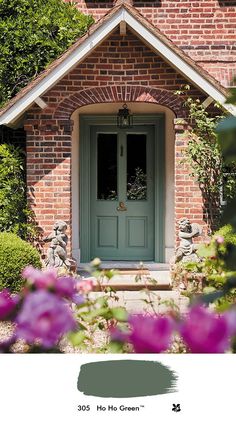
[0,266,87,352]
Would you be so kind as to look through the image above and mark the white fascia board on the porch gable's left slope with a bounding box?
[0,9,124,125]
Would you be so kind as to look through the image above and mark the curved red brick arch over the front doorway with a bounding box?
[54,85,186,120]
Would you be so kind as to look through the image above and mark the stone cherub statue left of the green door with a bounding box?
[44,221,71,268]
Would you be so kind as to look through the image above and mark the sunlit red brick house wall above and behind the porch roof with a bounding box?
[64,0,236,86]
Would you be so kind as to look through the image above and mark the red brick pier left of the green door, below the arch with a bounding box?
[24,115,71,247]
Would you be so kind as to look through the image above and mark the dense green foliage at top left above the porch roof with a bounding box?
[0,0,93,106]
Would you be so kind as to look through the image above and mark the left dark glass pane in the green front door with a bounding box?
[97,133,117,200]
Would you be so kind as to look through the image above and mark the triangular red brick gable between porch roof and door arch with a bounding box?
[43,31,205,118]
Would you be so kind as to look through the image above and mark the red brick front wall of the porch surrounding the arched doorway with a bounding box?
[25,29,208,256]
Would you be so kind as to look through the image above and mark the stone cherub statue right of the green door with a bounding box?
[175,218,202,263]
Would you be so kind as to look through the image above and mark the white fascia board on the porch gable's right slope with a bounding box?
[124,10,236,115]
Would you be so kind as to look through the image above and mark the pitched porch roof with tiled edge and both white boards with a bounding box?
[0,3,236,126]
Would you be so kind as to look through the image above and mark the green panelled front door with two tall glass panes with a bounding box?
[90,125,155,260]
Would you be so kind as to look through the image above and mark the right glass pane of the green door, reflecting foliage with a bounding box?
[127,134,147,200]
